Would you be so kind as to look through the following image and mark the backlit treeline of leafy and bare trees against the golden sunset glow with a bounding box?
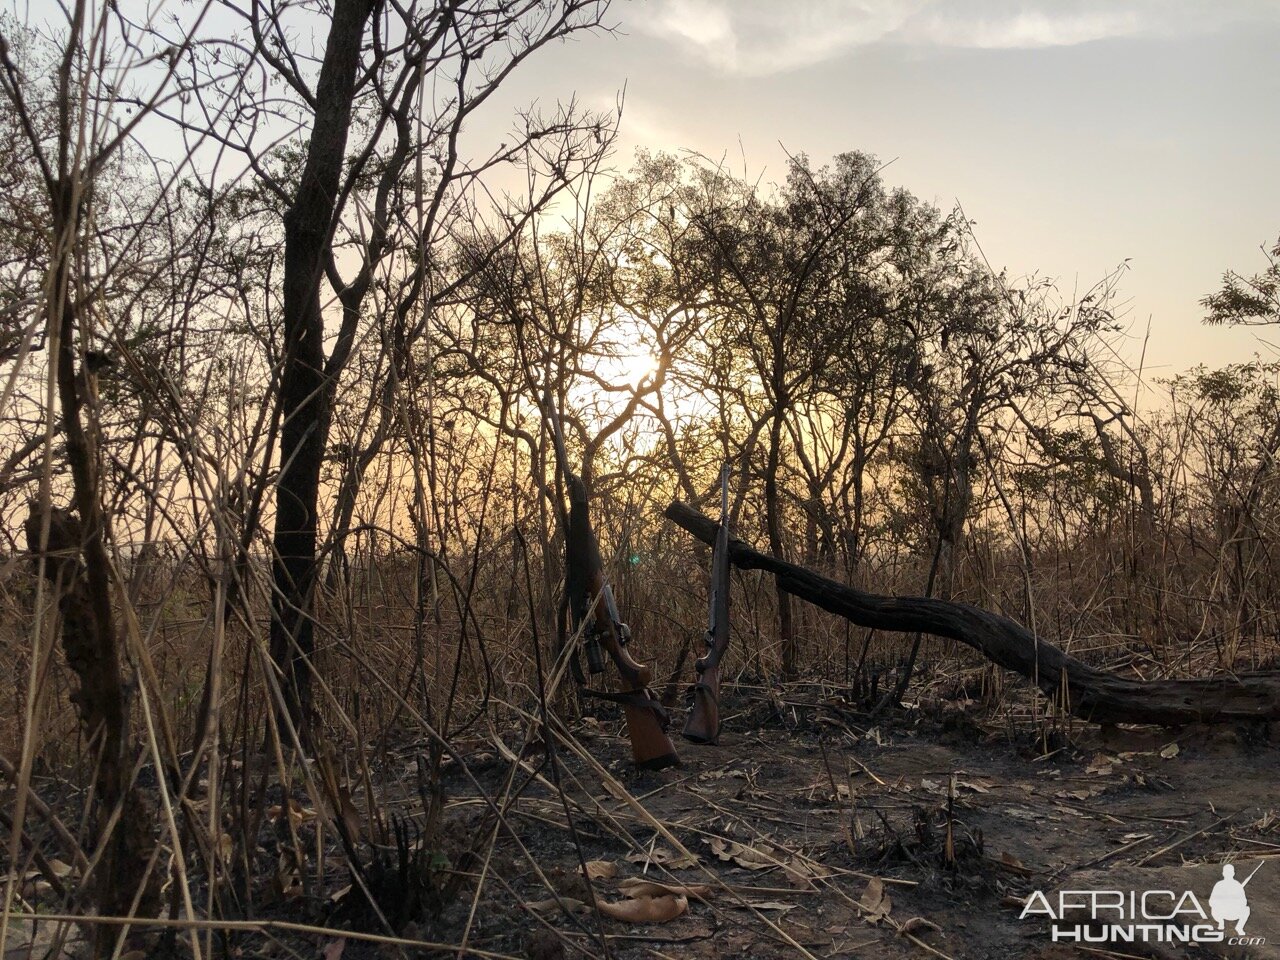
[5,131,1280,691]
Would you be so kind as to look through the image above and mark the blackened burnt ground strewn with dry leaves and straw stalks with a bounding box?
[2,685,1280,960]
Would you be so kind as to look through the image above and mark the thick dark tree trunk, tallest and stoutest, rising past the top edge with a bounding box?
[271,0,375,730]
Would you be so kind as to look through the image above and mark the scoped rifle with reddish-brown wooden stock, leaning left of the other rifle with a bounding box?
[543,394,678,771]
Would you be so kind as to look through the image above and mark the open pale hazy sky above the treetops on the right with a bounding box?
[478,0,1280,375]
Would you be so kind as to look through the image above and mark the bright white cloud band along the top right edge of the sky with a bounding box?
[639,0,1280,76]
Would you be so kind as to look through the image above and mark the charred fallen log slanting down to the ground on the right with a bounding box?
[666,500,1280,726]
